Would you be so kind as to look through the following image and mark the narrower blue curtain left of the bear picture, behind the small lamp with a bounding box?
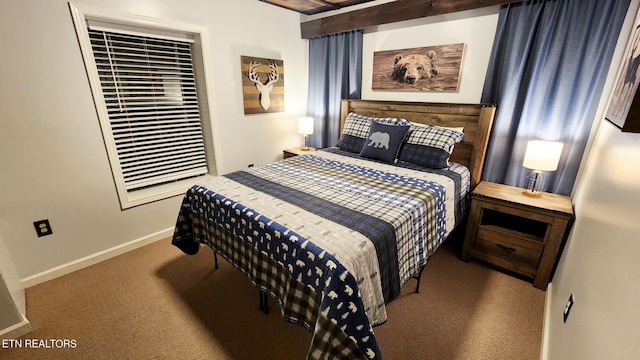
[307,30,363,148]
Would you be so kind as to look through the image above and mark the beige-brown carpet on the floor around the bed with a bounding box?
[0,239,544,360]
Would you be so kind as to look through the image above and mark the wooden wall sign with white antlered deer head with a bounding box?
[240,56,284,114]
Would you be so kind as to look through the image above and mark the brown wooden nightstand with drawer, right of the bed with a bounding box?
[461,181,574,290]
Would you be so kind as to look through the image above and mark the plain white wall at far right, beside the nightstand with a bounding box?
[543,0,640,360]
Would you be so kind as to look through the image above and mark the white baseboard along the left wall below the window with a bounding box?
[21,227,174,289]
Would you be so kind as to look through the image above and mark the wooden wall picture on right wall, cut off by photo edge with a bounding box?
[605,25,640,133]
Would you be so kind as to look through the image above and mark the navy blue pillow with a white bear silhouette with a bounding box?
[360,121,409,164]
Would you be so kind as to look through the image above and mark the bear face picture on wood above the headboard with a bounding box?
[371,44,464,91]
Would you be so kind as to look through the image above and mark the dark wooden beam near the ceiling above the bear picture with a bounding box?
[300,0,522,39]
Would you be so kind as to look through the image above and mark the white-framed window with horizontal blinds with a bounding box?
[70,5,215,209]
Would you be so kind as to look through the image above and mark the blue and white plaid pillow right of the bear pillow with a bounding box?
[398,125,464,169]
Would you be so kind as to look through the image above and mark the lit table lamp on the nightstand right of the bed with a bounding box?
[522,140,563,197]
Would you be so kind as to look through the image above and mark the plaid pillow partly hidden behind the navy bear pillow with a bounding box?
[337,113,409,153]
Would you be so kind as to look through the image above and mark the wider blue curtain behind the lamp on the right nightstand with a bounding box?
[482,0,630,195]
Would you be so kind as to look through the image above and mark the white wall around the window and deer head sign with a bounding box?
[0,0,308,278]
